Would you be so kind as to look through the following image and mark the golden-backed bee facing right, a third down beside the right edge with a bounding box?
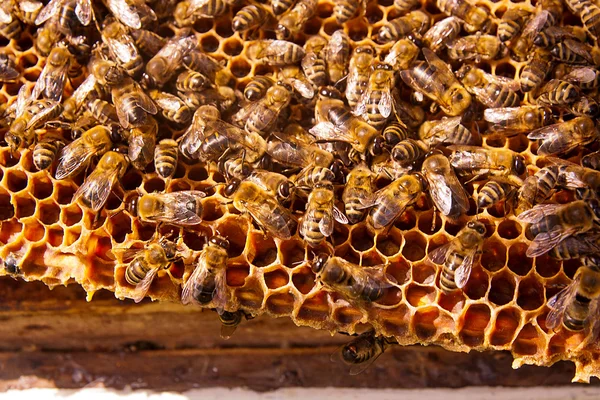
[527,117,598,156]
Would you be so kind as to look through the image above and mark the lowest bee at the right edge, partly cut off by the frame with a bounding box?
[546,255,600,336]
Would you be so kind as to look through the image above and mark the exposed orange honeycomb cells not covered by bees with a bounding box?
[0,0,600,381]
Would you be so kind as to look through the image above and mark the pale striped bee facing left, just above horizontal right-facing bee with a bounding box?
[419,116,476,148]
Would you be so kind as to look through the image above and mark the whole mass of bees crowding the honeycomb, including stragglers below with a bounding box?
[0,0,600,372]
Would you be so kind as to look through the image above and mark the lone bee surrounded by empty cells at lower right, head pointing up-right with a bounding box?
[428,221,486,293]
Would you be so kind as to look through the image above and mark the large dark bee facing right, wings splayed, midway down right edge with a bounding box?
[519,199,600,257]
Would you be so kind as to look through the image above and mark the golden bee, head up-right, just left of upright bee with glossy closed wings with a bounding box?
[363,174,423,229]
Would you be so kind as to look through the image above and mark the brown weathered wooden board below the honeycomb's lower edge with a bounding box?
[0,279,596,391]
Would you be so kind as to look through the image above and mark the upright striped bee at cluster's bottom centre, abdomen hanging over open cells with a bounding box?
[300,182,348,247]
